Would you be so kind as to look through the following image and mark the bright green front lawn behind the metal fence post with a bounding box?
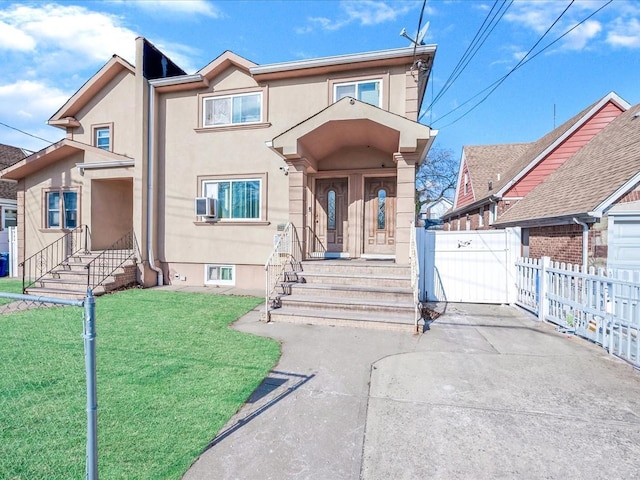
[0,284,280,480]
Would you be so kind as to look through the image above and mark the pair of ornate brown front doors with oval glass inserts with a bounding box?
[314,177,396,255]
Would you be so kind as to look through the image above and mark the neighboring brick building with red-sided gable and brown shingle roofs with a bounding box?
[444,93,640,268]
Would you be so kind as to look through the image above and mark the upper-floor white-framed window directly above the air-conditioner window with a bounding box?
[202,92,262,127]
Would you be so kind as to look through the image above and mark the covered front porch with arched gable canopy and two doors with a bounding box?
[270,98,436,264]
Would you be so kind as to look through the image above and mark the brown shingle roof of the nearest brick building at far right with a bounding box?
[495,104,640,226]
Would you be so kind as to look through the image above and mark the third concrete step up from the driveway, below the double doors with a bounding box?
[290,283,413,303]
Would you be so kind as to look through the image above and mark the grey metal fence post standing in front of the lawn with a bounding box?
[82,290,98,480]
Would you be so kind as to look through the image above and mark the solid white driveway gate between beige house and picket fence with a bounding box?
[417,228,521,303]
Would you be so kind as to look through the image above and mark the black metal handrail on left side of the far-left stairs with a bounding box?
[20,225,91,293]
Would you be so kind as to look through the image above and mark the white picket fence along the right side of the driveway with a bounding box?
[516,257,640,367]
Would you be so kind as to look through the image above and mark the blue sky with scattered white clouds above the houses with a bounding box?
[0,0,640,157]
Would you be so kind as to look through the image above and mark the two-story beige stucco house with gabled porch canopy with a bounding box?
[2,38,436,288]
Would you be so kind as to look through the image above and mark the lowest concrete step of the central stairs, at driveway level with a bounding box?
[271,307,415,332]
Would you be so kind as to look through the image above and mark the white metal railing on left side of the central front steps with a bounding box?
[264,223,302,322]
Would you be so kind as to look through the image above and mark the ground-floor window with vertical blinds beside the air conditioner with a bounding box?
[202,178,262,220]
